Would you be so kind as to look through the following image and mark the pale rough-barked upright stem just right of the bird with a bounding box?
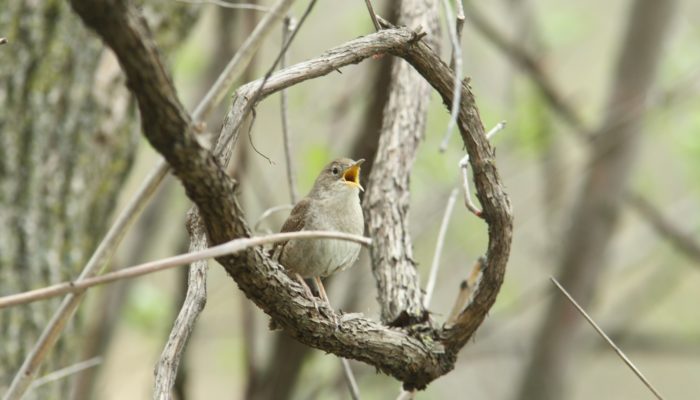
[363,0,439,326]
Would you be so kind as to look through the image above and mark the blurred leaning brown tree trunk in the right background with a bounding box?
[517,0,675,400]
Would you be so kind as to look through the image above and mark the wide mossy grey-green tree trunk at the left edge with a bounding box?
[0,1,137,398]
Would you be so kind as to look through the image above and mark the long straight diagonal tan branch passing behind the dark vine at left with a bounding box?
[5,0,293,400]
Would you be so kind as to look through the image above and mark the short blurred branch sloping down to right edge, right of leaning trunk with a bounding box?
[625,193,700,261]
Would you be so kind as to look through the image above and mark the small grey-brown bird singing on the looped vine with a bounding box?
[276,158,365,305]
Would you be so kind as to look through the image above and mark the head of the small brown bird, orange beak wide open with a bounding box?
[311,158,365,197]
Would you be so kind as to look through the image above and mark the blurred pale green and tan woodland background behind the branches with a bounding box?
[0,0,700,399]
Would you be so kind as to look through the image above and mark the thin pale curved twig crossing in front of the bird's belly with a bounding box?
[0,231,372,309]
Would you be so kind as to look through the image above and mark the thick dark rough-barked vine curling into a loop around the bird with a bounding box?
[72,0,512,389]
